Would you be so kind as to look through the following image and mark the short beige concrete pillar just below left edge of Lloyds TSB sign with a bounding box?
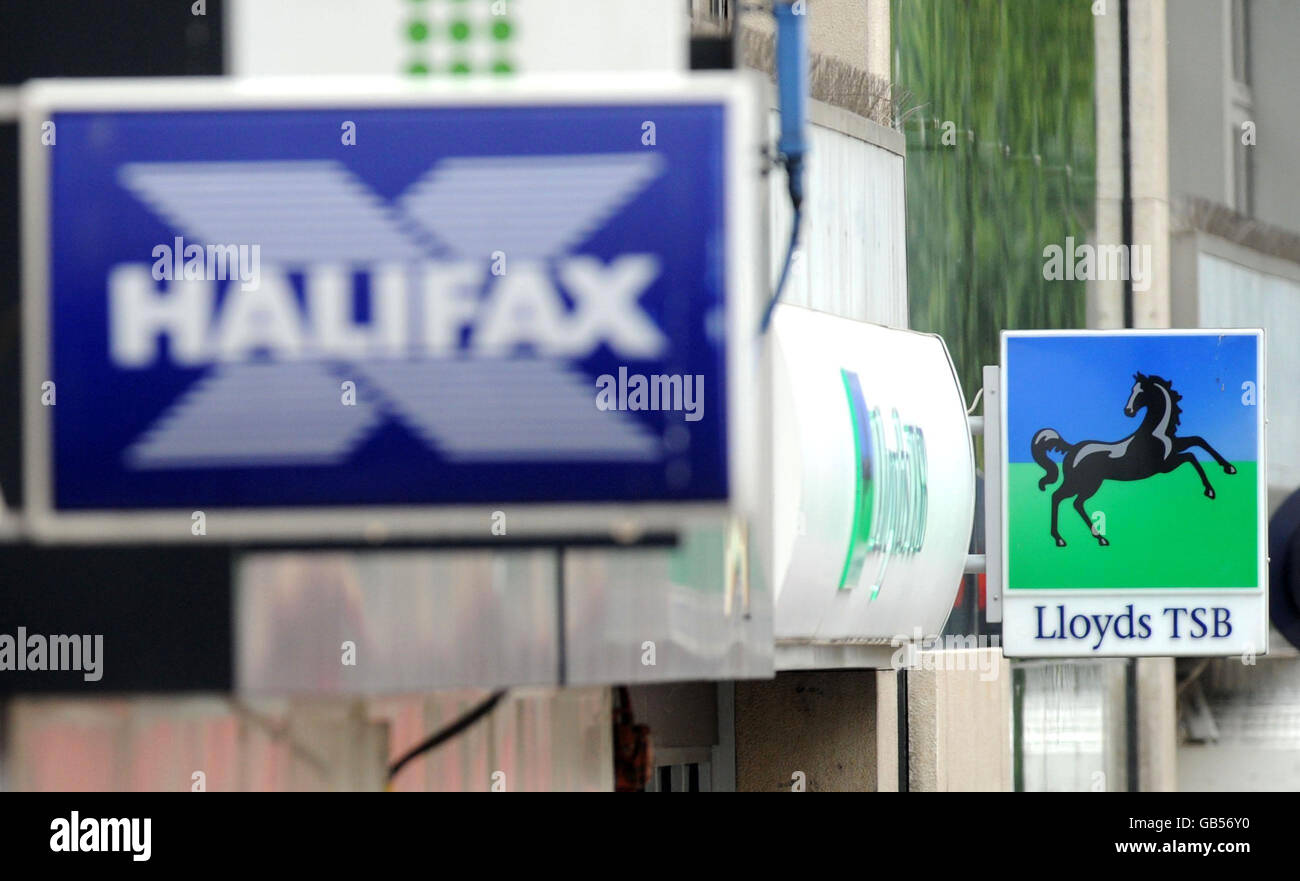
[907,648,1011,793]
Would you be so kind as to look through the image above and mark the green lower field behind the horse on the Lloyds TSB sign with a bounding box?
[1006,461,1260,590]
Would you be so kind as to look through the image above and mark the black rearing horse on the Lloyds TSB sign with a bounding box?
[1032,373,1236,547]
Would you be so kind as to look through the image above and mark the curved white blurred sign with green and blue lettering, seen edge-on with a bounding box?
[772,305,975,642]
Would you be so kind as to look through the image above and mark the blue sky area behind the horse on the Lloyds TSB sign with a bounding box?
[1004,334,1258,463]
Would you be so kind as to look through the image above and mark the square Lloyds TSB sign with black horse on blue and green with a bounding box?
[1001,330,1268,656]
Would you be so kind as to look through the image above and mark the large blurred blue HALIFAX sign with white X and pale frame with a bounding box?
[23,77,749,538]
